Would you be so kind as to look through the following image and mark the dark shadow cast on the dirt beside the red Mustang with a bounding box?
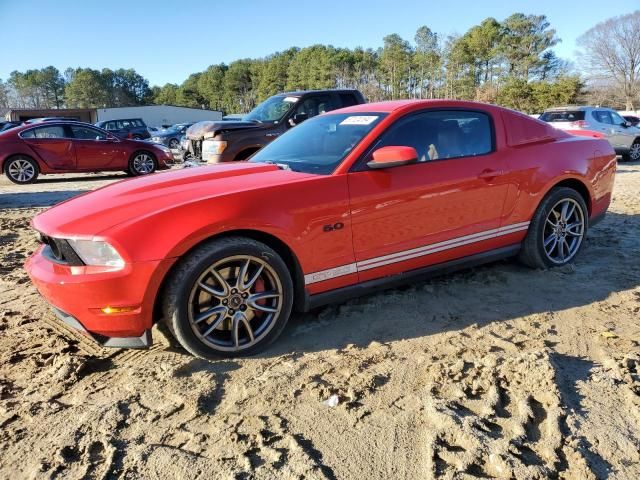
[259,213,640,357]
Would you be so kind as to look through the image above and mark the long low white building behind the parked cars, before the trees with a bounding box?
[97,105,222,127]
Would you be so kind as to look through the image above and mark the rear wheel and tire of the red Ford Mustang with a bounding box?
[519,187,589,268]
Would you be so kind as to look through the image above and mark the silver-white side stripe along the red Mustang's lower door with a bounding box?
[304,222,531,285]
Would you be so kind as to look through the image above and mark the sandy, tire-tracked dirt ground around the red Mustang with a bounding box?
[0,164,640,480]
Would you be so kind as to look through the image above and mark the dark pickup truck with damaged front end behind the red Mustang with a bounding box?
[182,90,365,163]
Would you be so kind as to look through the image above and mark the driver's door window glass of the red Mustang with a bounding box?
[368,110,493,162]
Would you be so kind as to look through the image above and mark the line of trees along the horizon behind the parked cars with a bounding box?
[0,12,640,113]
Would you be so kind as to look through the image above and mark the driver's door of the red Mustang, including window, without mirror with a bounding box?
[348,111,508,282]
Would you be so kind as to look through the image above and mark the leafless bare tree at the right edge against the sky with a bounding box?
[578,10,640,110]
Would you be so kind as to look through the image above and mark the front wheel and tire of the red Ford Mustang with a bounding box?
[162,237,293,359]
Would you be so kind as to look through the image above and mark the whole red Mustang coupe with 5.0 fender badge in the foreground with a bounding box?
[26,101,616,358]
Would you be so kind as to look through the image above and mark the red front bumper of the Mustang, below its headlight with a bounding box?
[25,247,171,348]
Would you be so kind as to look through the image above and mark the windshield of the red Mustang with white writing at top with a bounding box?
[250,113,386,175]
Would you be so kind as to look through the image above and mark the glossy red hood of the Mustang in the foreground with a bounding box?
[32,162,312,238]
